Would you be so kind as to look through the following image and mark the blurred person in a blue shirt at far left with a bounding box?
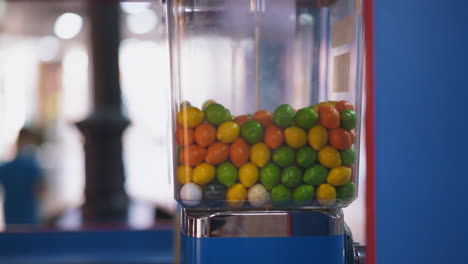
[0,128,42,228]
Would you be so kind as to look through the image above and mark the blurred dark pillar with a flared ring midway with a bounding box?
[77,1,129,223]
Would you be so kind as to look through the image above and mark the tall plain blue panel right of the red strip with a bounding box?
[374,0,468,264]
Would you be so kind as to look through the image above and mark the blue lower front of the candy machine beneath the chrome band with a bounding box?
[181,235,344,264]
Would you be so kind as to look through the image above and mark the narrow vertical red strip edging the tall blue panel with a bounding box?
[364,0,376,264]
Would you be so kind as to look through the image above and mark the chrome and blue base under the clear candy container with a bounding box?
[177,208,364,264]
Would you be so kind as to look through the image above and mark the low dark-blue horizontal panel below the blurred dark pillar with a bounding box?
[0,229,174,264]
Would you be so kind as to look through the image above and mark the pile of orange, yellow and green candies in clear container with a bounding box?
[175,100,359,208]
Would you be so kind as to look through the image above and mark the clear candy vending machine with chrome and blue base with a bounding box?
[166,0,364,264]
